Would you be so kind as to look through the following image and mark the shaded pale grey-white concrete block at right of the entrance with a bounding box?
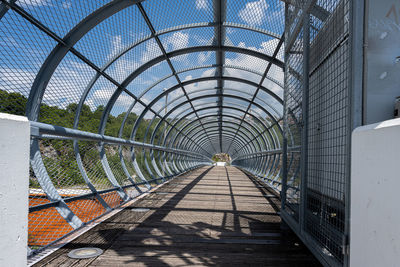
[350,119,400,267]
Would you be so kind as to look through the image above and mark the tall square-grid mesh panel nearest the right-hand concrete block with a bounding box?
[306,1,350,263]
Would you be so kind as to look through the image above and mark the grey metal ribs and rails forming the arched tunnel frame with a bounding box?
[0,0,312,258]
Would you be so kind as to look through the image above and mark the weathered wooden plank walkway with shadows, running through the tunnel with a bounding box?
[35,167,320,267]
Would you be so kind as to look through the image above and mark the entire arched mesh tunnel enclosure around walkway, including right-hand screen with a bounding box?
[0,0,350,264]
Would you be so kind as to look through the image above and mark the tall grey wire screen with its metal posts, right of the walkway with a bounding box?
[285,0,351,266]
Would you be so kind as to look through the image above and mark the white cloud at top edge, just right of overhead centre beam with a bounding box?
[238,0,268,26]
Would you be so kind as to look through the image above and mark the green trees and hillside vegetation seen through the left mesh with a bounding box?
[0,90,164,188]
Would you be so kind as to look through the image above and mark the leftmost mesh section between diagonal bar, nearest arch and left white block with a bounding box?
[0,10,56,115]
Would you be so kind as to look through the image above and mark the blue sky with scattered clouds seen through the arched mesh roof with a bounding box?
[0,0,284,120]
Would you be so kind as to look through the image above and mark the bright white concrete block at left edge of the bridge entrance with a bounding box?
[0,113,30,267]
